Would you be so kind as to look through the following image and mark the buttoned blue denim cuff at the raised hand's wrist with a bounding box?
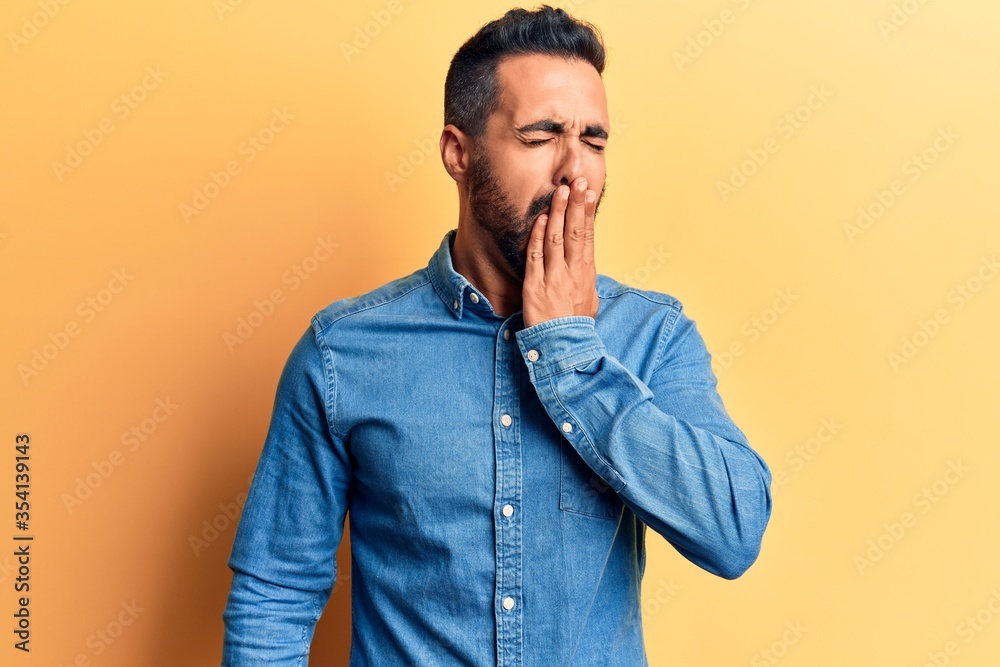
[514,315,606,382]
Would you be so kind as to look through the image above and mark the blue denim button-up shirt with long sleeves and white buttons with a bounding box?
[223,229,771,667]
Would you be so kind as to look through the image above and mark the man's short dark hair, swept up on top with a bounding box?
[444,5,606,138]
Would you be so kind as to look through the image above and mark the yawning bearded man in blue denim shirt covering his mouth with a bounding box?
[224,6,771,667]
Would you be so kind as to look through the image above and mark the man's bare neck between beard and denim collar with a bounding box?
[451,220,523,317]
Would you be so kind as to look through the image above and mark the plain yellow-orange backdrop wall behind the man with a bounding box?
[0,0,1000,667]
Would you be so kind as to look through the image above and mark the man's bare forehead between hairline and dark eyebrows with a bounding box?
[497,54,608,126]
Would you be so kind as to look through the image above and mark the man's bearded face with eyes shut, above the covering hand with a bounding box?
[468,55,609,281]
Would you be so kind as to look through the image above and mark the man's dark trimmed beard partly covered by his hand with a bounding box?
[469,153,604,282]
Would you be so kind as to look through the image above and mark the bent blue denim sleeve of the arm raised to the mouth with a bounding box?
[516,310,771,579]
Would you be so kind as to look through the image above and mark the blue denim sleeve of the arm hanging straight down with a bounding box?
[222,329,351,667]
